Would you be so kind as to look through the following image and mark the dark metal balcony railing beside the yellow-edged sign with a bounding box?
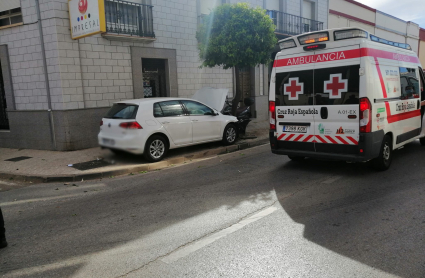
[105,0,155,38]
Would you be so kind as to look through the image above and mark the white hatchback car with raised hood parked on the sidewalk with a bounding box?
[98,98,238,161]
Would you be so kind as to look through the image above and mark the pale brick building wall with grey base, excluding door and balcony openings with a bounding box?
[0,0,327,150]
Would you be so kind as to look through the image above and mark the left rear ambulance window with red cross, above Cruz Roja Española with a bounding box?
[275,70,313,106]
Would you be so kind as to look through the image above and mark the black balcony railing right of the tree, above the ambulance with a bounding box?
[267,10,323,35]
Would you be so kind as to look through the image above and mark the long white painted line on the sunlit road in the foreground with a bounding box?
[161,206,278,264]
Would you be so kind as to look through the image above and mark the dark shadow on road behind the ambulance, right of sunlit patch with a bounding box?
[271,142,425,277]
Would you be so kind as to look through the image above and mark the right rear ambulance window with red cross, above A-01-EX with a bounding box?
[314,65,360,105]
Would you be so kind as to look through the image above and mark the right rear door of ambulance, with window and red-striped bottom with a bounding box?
[314,45,361,154]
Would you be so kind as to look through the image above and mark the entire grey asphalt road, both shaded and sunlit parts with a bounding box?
[0,142,425,277]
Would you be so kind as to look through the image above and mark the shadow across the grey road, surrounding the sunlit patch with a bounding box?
[0,143,425,277]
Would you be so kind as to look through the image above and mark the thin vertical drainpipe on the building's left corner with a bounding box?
[35,0,57,150]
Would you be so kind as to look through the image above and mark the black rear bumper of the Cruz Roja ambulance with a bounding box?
[269,130,384,162]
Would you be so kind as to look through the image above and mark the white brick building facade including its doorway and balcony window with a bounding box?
[0,0,328,150]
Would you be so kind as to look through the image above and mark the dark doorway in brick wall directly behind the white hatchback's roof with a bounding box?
[142,58,167,98]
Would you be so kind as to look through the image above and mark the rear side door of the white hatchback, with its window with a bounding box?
[154,100,193,146]
